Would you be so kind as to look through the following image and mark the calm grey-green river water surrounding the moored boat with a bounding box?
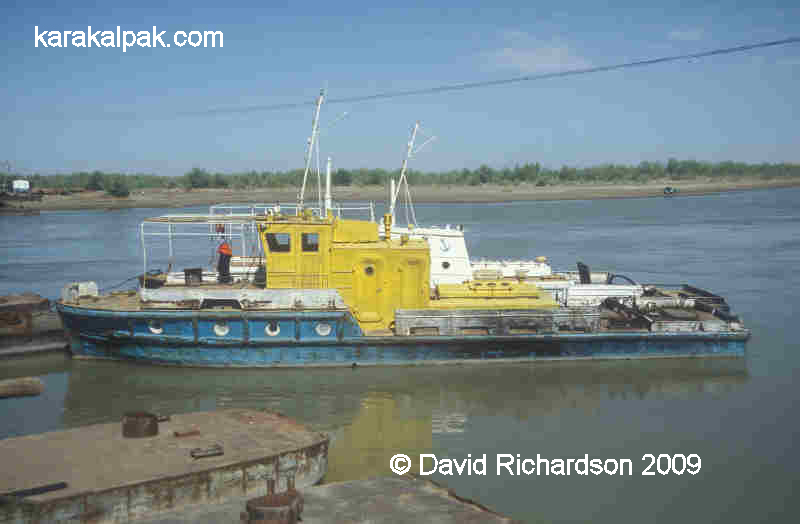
[0,189,800,524]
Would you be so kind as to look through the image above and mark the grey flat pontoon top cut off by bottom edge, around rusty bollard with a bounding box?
[141,475,514,524]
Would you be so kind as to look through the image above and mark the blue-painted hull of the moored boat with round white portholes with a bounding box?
[57,304,749,367]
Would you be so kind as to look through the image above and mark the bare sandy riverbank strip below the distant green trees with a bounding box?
[12,178,800,210]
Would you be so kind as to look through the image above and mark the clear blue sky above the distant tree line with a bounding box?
[0,0,800,175]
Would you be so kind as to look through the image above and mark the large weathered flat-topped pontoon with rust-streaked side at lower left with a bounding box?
[0,409,329,524]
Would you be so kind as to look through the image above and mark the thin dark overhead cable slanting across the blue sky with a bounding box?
[180,37,800,116]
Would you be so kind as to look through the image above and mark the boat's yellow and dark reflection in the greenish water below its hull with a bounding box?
[62,359,749,481]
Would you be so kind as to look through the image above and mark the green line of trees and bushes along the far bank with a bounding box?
[0,159,800,197]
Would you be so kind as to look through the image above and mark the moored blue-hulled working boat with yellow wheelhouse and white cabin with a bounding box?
[56,91,750,367]
